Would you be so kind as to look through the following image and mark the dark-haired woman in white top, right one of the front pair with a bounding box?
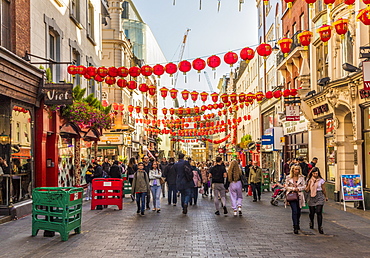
[306,167,328,234]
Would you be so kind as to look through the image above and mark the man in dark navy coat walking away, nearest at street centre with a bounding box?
[174,153,194,214]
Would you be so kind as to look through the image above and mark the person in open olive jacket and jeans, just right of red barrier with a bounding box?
[131,162,150,216]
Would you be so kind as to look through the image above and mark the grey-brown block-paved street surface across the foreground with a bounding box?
[0,192,370,257]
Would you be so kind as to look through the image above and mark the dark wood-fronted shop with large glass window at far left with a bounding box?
[0,47,44,216]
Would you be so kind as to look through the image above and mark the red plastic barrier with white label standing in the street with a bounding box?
[91,178,123,210]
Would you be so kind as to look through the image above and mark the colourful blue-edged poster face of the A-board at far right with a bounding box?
[341,175,364,202]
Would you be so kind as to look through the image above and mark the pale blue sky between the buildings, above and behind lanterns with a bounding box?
[134,0,258,94]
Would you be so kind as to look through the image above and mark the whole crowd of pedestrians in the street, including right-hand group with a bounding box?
[86,153,328,234]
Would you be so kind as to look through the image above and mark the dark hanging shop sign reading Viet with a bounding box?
[42,83,73,105]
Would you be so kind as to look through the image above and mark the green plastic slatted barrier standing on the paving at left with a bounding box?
[32,187,83,241]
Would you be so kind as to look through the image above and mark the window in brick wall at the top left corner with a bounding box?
[0,0,11,50]
